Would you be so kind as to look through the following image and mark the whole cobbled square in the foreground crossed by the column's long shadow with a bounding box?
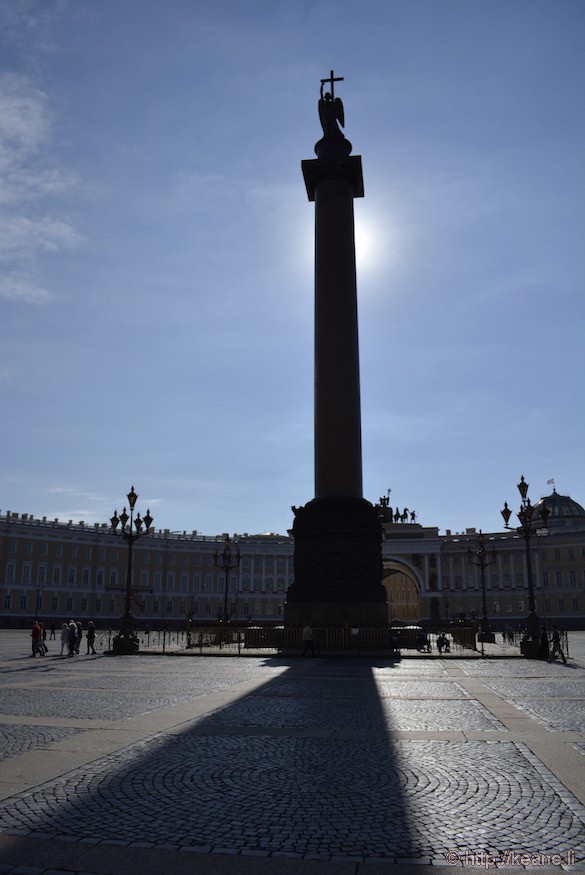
[0,633,585,875]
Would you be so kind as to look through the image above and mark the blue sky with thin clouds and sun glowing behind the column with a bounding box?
[0,0,585,535]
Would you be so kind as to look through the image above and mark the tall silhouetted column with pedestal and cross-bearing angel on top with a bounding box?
[285,70,388,627]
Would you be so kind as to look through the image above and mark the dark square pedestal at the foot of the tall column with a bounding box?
[284,498,389,628]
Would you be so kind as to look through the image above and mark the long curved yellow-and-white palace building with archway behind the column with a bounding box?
[0,490,585,630]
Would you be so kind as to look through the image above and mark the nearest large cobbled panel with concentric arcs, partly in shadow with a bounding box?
[0,734,585,859]
